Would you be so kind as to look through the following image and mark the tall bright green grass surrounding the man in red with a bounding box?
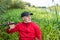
[0,7,60,40]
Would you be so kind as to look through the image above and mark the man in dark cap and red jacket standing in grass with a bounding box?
[6,11,42,40]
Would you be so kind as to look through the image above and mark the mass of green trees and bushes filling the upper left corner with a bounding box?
[0,0,25,15]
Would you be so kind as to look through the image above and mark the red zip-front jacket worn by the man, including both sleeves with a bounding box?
[6,22,42,40]
